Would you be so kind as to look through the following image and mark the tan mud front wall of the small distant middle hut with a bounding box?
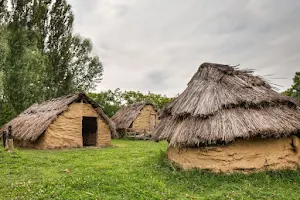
[132,105,159,131]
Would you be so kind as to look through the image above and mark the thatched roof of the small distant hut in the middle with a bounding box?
[111,101,156,129]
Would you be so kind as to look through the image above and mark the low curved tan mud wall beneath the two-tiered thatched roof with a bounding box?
[167,136,300,173]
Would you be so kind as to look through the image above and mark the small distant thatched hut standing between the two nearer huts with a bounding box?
[111,102,159,136]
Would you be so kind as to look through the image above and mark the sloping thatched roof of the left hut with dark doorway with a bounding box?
[1,93,118,141]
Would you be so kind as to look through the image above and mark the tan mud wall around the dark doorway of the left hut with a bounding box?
[17,103,111,149]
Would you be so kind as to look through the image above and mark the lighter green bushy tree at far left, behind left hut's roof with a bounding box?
[3,29,46,113]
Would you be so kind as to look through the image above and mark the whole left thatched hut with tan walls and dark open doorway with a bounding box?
[1,93,116,149]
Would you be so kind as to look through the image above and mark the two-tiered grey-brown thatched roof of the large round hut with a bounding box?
[153,63,300,147]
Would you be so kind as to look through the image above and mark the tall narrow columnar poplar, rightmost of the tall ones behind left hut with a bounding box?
[43,0,74,98]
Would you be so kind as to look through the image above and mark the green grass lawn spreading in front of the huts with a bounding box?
[0,140,300,200]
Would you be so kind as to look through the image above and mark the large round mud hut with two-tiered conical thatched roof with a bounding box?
[153,63,300,172]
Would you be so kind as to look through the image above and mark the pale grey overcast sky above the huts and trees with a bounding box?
[69,0,300,96]
